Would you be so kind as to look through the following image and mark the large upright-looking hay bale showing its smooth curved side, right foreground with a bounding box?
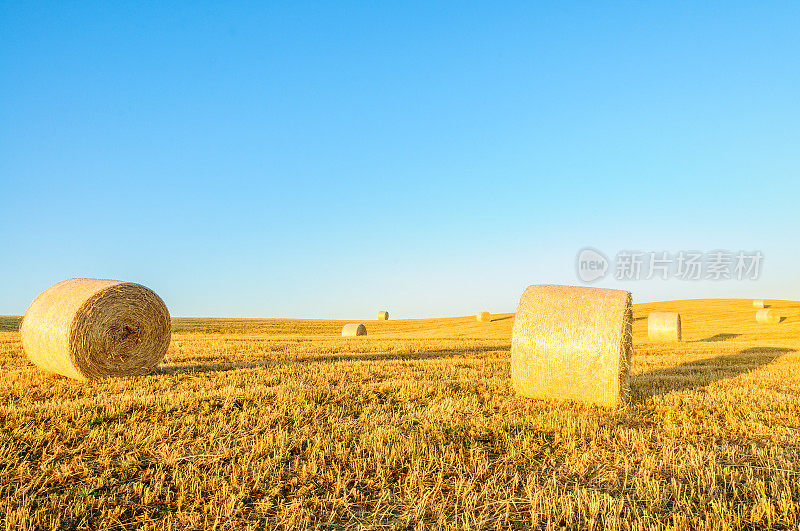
[511,285,633,406]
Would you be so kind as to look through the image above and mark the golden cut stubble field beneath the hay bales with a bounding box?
[0,300,800,529]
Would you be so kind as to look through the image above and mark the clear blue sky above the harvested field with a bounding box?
[0,1,800,319]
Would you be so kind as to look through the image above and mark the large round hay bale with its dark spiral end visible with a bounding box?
[20,278,172,380]
